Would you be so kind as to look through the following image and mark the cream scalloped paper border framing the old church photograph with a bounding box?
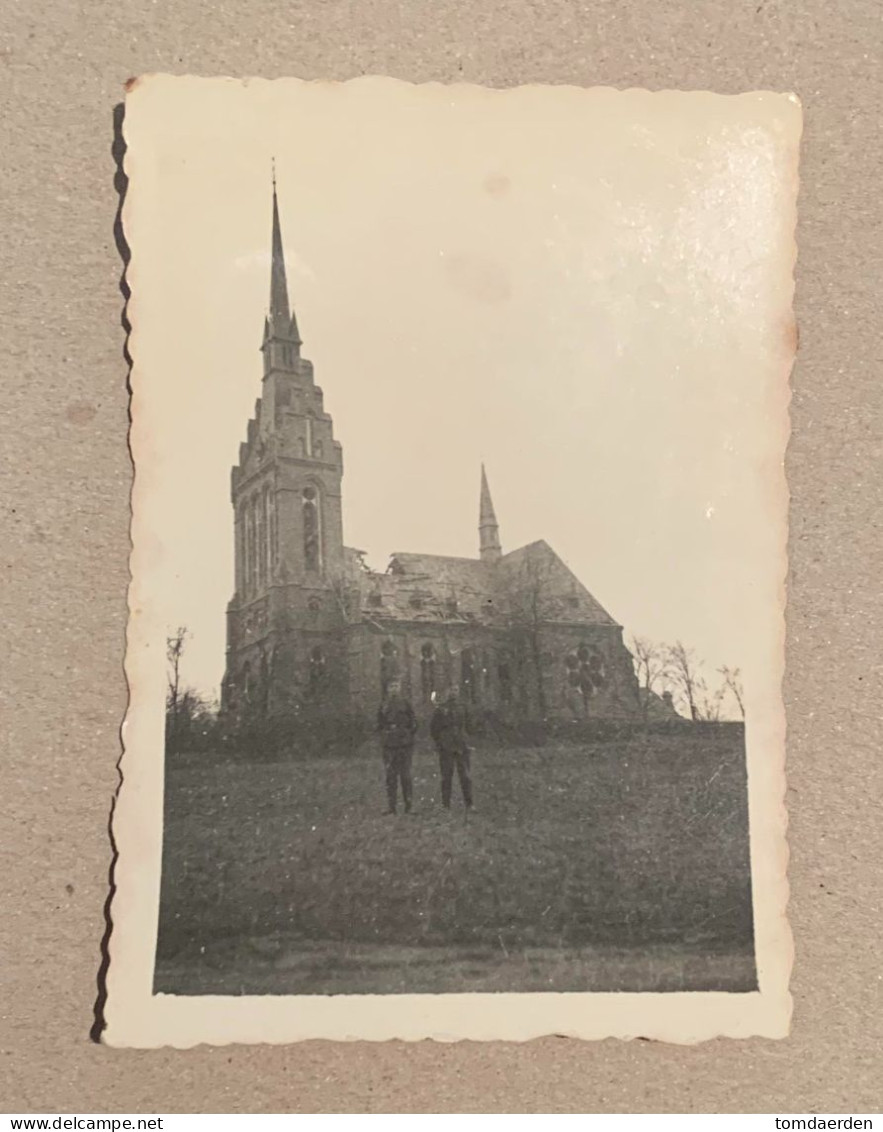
[102,75,799,1048]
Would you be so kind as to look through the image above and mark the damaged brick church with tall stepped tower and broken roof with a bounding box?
[222,185,640,720]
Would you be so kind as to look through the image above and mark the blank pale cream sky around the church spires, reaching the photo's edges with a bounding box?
[123,79,799,715]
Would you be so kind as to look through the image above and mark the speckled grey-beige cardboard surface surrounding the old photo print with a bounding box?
[0,0,883,1113]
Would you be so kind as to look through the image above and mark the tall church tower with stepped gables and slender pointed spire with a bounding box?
[222,177,344,713]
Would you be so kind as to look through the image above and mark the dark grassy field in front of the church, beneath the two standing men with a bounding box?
[156,729,755,994]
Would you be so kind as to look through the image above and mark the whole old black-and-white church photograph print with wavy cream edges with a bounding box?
[109,76,800,1045]
